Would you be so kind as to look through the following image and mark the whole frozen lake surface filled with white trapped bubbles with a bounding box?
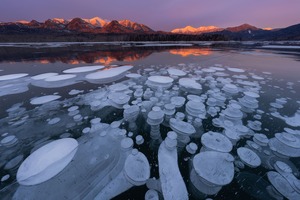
[0,43,300,199]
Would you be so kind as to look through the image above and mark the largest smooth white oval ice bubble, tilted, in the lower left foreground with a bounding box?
[17,138,78,185]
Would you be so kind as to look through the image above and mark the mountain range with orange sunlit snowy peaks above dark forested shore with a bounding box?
[0,17,300,41]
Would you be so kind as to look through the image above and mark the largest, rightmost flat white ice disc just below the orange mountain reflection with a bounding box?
[85,65,133,83]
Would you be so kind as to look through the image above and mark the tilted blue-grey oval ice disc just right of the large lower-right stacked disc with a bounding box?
[237,147,261,168]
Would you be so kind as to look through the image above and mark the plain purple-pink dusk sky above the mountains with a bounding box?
[0,0,300,31]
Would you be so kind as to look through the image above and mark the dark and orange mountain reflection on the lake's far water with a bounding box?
[0,45,212,65]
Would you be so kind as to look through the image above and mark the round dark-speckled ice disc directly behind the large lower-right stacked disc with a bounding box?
[201,131,232,153]
